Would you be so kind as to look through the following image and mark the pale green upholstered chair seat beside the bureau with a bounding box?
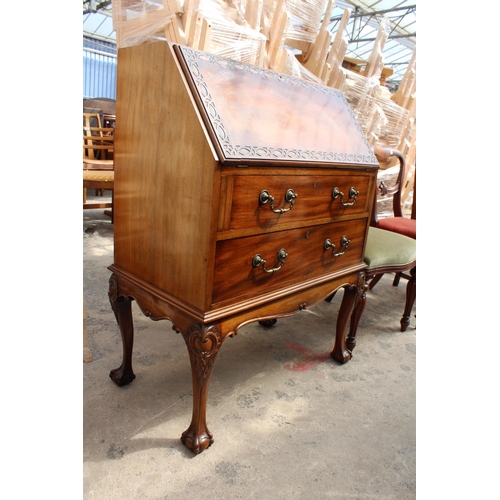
[365,227,417,270]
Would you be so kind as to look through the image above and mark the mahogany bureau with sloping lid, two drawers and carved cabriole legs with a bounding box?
[109,42,378,453]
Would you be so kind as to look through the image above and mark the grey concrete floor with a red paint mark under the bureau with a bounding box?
[83,204,416,500]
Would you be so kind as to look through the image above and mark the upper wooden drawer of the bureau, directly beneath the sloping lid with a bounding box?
[226,173,370,230]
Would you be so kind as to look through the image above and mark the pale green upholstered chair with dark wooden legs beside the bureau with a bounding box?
[346,227,417,351]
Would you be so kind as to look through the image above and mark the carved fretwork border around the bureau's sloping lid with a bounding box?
[179,46,377,165]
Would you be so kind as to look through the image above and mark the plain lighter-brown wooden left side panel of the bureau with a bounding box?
[114,43,218,310]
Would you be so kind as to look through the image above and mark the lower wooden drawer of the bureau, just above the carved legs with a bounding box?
[212,218,368,304]
